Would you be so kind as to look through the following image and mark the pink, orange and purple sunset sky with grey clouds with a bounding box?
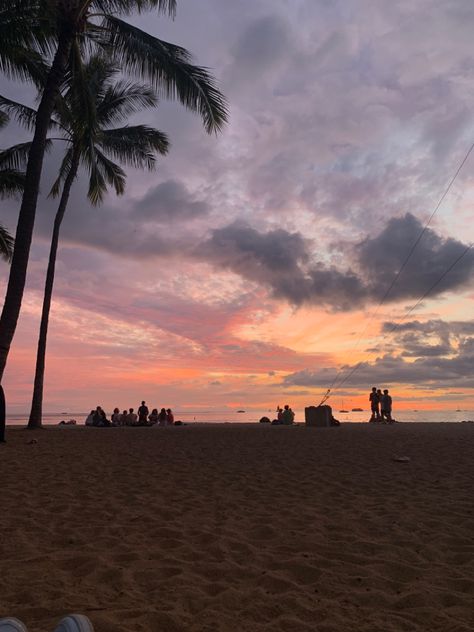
[0,0,474,413]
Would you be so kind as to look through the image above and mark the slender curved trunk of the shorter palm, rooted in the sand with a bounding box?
[28,150,80,428]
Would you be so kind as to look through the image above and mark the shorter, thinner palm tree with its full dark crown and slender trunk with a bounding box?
[5,56,169,428]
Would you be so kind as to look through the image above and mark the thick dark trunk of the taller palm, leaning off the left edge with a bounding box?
[0,29,72,381]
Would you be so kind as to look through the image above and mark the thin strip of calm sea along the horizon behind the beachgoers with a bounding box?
[7,409,474,425]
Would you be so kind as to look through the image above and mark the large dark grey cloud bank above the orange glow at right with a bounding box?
[195,214,474,310]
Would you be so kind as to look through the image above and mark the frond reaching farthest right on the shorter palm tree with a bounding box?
[99,125,170,169]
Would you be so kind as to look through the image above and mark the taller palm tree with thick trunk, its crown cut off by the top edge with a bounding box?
[0,0,227,381]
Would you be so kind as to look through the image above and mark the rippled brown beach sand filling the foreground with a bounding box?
[0,424,474,632]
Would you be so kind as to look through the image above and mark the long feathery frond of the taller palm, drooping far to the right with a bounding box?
[95,15,228,133]
